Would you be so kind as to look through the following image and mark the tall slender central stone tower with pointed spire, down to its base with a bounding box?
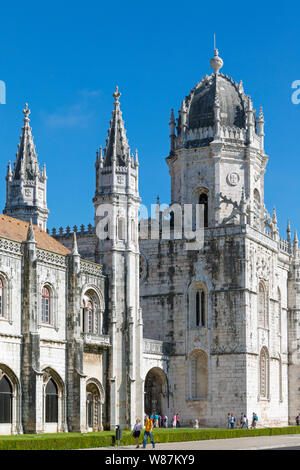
[93,87,144,429]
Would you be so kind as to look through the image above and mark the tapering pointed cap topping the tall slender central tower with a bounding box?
[104,86,129,166]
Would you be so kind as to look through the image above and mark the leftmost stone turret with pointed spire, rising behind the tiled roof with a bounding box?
[3,103,49,230]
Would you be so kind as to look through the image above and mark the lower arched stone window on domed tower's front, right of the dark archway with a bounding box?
[190,351,208,400]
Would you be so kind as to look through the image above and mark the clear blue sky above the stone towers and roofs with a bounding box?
[0,0,300,236]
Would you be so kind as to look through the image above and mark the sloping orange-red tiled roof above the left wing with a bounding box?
[0,214,71,255]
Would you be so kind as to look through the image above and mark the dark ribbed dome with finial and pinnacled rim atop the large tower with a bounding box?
[170,49,262,153]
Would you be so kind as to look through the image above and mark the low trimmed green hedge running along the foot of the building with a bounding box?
[0,426,300,450]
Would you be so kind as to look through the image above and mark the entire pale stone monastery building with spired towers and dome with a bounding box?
[0,50,300,434]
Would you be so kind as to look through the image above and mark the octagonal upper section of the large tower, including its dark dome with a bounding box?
[167,49,268,230]
